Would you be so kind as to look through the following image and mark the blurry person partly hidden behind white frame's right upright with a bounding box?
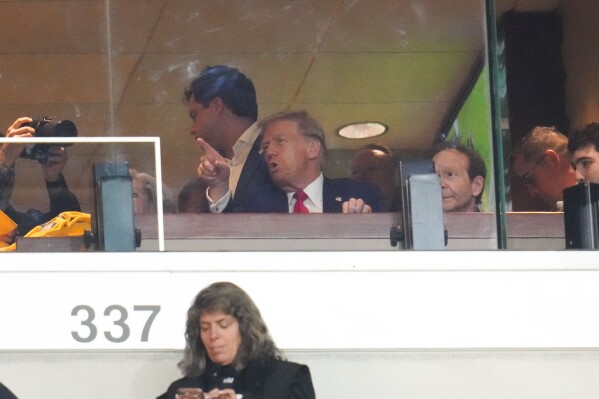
[129,169,177,215]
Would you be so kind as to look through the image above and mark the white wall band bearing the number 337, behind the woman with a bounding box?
[0,252,599,350]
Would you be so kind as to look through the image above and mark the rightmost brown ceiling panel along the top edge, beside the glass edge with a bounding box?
[321,0,484,53]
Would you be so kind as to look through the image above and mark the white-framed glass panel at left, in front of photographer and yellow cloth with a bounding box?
[0,136,164,252]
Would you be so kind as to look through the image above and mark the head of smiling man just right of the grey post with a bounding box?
[433,149,484,212]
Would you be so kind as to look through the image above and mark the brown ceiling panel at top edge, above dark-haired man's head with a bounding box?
[137,0,335,55]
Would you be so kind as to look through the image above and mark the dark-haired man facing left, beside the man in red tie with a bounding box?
[184,65,271,213]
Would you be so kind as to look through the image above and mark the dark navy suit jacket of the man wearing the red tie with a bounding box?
[233,177,388,213]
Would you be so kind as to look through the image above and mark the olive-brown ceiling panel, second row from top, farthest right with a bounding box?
[297,52,477,103]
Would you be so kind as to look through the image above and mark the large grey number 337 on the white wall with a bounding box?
[71,305,160,343]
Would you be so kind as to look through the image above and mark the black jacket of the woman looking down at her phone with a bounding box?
[157,359,315,399]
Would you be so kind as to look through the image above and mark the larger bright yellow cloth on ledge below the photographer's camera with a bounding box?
[0,211,92,252]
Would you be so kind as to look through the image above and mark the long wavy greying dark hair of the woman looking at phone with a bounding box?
[179,282,283,377]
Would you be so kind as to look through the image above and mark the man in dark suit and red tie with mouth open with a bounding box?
[233,111,385,213]
